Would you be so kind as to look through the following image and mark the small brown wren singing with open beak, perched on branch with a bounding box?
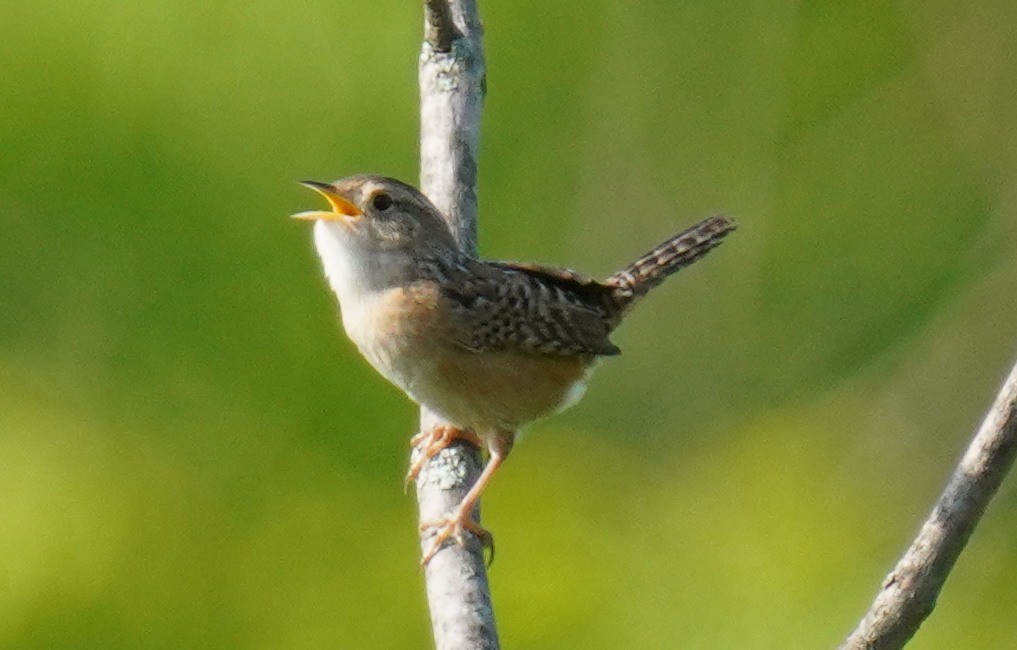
[292,174,735,565]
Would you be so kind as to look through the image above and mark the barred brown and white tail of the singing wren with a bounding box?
[604,217,735,312]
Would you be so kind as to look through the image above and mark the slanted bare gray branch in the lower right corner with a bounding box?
[841,358,1017,650]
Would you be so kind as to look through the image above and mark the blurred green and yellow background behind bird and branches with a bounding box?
[0,0,1017,649]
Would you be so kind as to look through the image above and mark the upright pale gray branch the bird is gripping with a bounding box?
[417,0,499,650]
